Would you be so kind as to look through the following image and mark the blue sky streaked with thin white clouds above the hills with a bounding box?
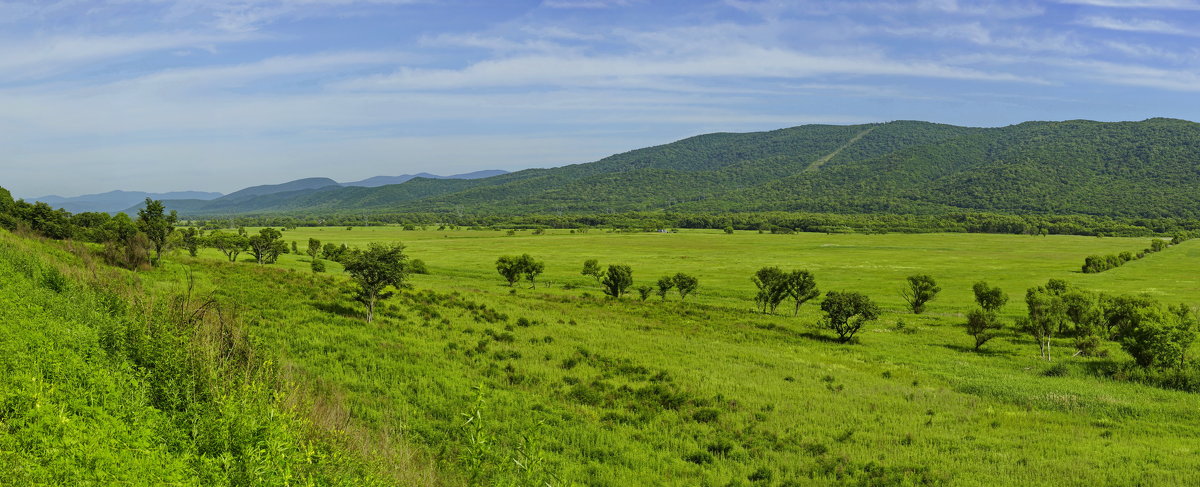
[0,0,1200,198]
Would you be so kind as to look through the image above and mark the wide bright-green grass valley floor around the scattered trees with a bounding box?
[162,227,1200,486]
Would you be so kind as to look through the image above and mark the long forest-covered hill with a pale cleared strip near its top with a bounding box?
[159,119,1200,217]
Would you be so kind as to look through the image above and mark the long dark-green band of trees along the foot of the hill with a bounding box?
[184,212,1200,236]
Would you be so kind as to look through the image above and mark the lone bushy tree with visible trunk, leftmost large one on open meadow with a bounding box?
[343,242,408,323]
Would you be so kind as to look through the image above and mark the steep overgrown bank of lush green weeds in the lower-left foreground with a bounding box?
[0,230,405,486]
